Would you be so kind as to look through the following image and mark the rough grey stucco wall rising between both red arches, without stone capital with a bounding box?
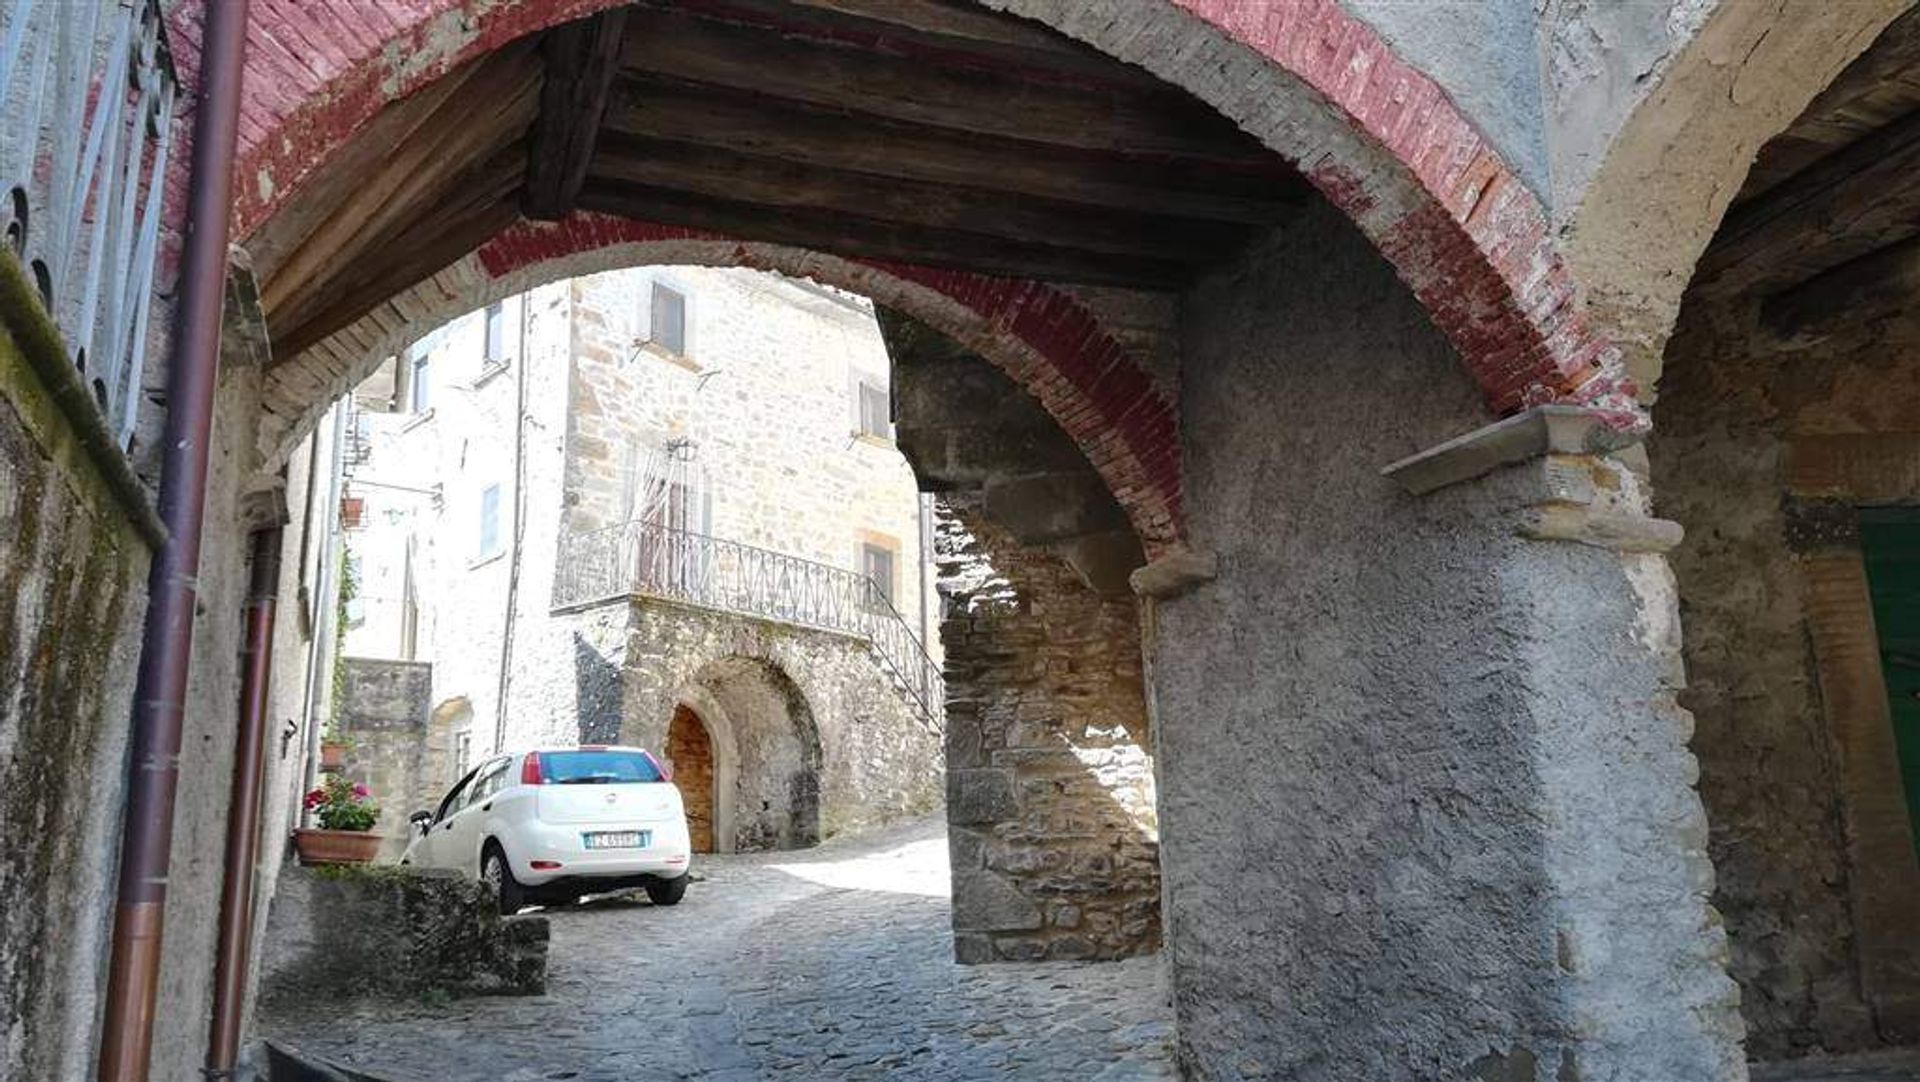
[1148,200,1740,1080]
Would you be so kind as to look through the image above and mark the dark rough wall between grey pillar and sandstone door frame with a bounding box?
[1649,295,1920,1059]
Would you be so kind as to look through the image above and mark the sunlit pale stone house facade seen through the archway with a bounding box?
[342,267,941,852]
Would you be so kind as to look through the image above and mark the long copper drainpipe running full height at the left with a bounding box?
[100,0,248,1082]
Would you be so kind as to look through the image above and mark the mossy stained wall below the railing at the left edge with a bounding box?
[0,334,150,1082]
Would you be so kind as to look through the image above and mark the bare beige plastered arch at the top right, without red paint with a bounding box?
[1567,0,1912,391]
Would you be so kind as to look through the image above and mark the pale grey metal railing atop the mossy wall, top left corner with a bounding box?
[0,0,179,449]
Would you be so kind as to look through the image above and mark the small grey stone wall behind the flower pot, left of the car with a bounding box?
[340,658,441,861]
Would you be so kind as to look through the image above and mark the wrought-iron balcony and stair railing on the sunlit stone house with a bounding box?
[553,522,947,725]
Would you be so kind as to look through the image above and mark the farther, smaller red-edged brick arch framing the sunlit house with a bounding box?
[259,215,1185,554]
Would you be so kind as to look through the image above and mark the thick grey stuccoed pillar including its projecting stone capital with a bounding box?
[1137,407,1745,1082]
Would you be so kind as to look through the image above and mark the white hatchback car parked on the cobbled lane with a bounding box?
[399,744,693,913]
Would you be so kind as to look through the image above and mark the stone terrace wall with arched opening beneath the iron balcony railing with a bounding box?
[507,599,943,852]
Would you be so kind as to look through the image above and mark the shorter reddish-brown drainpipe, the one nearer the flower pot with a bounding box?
[202,526,282,1080]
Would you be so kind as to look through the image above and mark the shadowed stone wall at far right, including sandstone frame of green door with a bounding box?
[1649,291,1920,1057]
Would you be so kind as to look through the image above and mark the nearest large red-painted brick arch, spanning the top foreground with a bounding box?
[220,0,1644,426]
